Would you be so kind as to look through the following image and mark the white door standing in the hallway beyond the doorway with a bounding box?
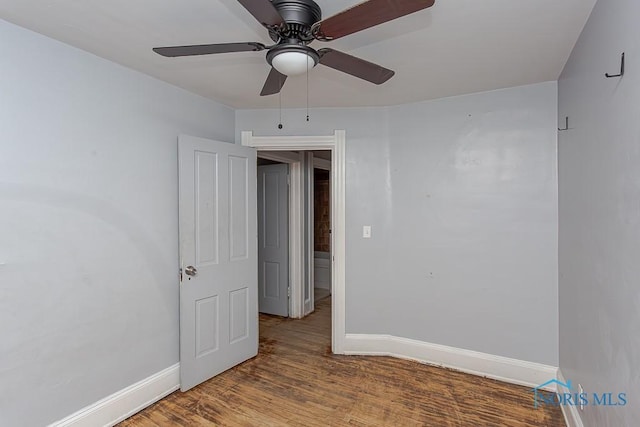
[258,164,289,317]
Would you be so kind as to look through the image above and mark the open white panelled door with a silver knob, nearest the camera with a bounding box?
[178,136,258,391]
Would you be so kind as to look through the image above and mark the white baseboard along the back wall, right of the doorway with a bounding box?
[344,334,558,391]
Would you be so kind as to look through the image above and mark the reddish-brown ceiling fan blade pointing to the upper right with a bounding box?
[312,0,435,41]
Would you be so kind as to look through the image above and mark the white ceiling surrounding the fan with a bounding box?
[0,0,596,108]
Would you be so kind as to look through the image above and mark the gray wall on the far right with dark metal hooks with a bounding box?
[558,0,640,427]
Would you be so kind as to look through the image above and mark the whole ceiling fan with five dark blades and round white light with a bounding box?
[153,0,435,96]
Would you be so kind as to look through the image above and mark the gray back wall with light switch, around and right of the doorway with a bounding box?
[236,82,558,366]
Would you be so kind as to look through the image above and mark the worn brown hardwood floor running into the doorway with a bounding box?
[120,298,565,427]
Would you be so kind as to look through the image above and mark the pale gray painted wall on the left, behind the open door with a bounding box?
[0,21,235,427]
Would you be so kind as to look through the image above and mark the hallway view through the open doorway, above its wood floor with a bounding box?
[257,150,332,318]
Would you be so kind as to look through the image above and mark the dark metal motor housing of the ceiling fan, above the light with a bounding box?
[269,0,322,44]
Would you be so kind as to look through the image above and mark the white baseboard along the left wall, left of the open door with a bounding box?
[49,363,180,427]
